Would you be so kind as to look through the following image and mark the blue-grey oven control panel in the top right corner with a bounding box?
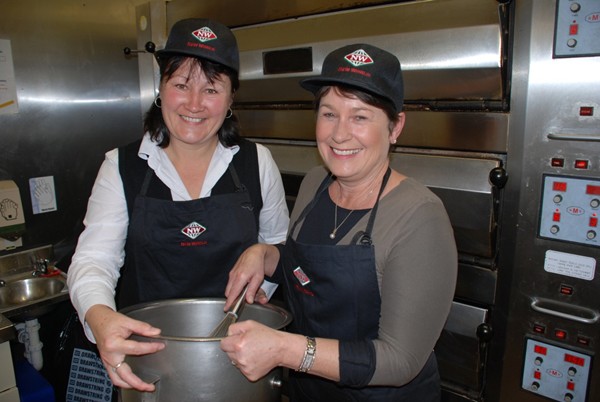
[554,0,600,57]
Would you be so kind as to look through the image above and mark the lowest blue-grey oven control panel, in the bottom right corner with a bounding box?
[521,339,592,402]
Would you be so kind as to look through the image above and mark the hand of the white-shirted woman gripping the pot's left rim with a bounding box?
[85,304,165,392]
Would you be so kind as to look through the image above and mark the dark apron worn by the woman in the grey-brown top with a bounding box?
[282,169,440,402]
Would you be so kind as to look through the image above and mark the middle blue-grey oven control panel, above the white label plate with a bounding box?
[538,175,600,247]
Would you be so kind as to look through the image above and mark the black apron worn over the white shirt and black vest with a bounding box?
[117,164,258,309]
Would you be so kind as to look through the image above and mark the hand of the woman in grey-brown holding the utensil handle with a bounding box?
[224,243,279,310]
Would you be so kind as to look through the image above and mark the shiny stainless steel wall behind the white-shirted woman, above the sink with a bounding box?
[0,0,148,257]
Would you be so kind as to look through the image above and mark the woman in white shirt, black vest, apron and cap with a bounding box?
[68,19,289,391]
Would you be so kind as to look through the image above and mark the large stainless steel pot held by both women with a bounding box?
[121,299,291,402]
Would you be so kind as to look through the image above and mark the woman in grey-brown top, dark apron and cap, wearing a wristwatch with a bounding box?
[221,44,457,402]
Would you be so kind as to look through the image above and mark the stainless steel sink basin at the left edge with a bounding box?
[0,272,69,320]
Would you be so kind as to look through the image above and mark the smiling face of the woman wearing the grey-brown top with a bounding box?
[316,87,404,183]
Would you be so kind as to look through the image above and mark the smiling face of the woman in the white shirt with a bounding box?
[160,58,233,150]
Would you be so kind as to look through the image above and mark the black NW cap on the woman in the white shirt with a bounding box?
[156,18,240,73]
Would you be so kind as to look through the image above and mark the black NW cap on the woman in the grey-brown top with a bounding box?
[300,43,404,112]
